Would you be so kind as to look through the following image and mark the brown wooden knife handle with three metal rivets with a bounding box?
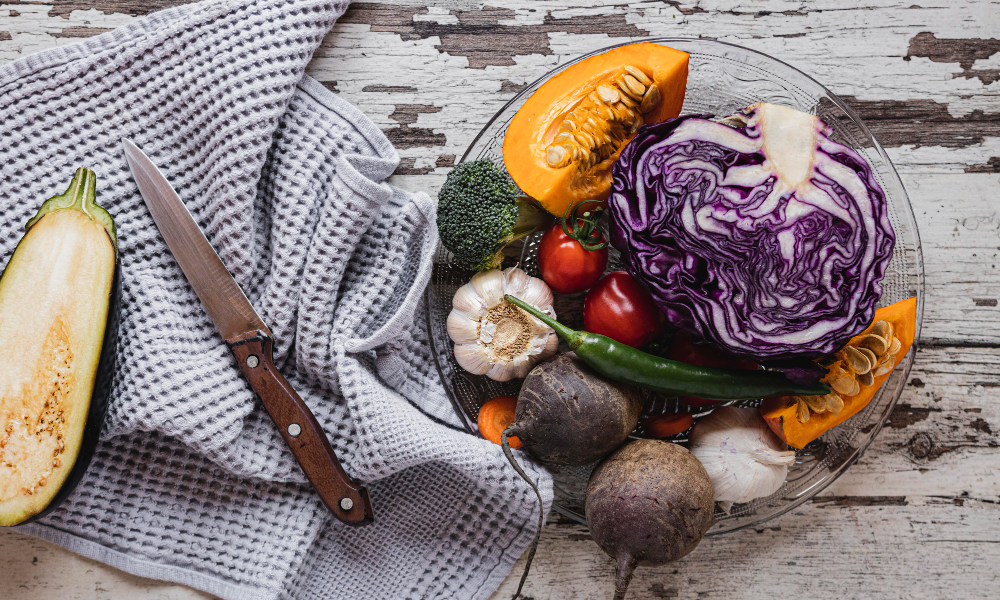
[226,331,375,525]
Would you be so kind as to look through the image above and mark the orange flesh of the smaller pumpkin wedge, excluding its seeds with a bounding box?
[760,298,917,448]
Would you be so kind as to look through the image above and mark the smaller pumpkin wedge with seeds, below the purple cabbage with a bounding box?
[760,298,917,448]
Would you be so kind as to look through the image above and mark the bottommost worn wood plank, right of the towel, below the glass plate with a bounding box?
[493,501,1000,600]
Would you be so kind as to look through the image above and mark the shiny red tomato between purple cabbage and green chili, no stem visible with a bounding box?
[583,271,666,348]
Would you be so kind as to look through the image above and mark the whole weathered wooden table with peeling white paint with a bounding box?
[0,0,1000,600]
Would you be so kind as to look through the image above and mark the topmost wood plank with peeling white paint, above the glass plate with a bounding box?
[0,0,1000,175]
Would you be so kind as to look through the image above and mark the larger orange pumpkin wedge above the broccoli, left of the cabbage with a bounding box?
[503,43,688,217]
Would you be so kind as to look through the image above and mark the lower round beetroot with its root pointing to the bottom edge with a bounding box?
[586,440,715,600]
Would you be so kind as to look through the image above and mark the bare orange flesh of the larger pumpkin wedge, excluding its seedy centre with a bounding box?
[503,42,688,217]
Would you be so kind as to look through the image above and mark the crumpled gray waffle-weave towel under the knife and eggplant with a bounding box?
[0,0,551,600]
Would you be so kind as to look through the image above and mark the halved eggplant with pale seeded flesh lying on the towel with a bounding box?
[0,169,121,525]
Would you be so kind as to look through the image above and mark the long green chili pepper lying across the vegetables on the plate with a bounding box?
[504,295,830,400]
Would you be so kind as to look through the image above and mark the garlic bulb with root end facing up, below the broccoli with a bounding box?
[448,267,559,381]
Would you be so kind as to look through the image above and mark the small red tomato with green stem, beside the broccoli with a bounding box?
[538,223,608,294]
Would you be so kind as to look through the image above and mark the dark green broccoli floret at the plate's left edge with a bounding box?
[437,158,552,271]
